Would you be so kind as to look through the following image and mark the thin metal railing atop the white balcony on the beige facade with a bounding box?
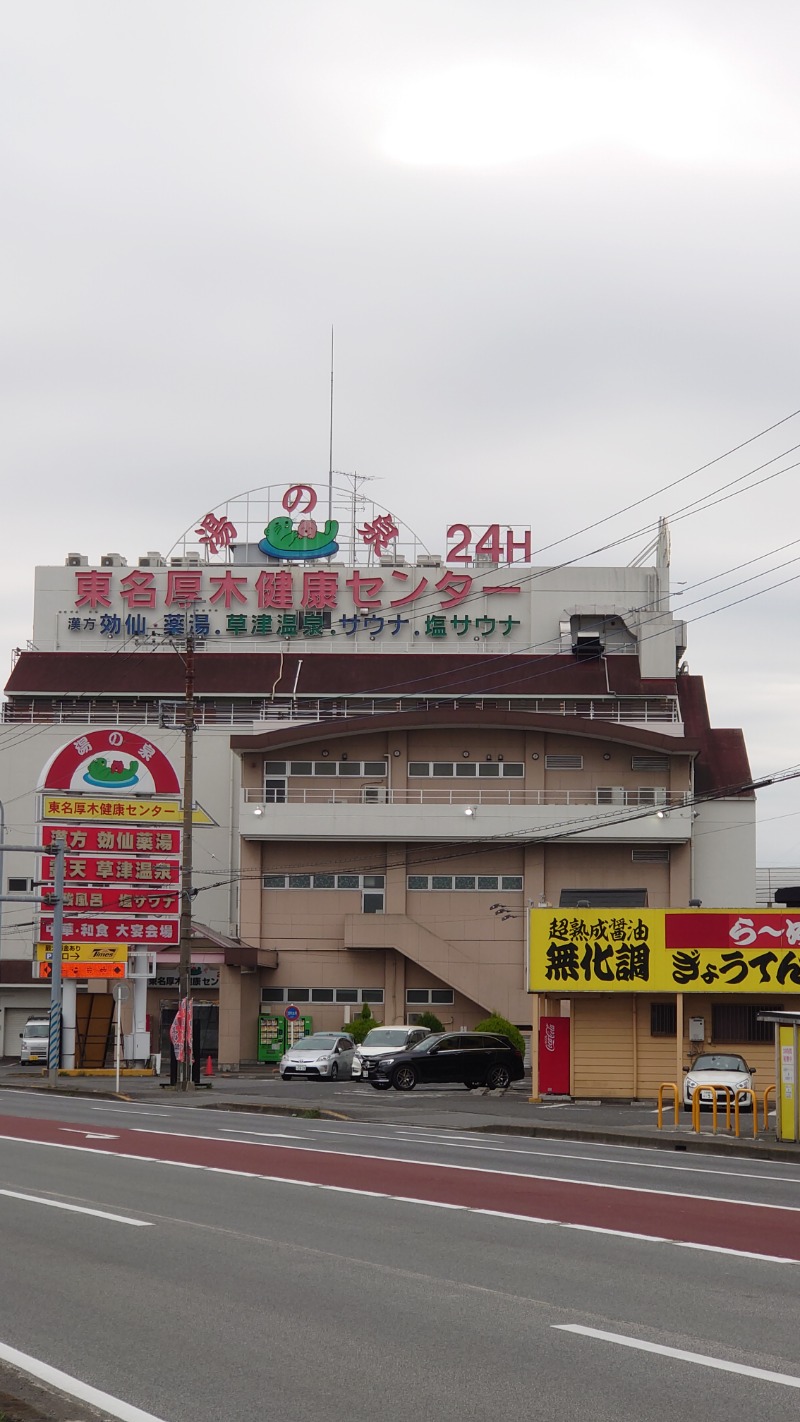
[242,784,686,813]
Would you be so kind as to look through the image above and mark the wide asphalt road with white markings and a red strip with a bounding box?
[0,1091,800,1422]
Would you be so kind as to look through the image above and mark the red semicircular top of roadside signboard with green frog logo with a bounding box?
[38,729,180,795]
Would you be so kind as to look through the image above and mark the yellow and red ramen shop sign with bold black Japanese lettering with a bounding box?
[530,909,800,995]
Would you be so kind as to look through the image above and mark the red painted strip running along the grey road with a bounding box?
[0,1116,800,1261]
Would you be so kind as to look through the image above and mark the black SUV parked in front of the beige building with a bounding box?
[374,1032,524,1091]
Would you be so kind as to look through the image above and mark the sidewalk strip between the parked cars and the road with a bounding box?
[0,1062,800,1163]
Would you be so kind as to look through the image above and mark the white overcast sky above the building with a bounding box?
[0,0,800,865]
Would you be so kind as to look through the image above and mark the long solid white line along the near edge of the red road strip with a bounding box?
[0,1136,800,1268]
